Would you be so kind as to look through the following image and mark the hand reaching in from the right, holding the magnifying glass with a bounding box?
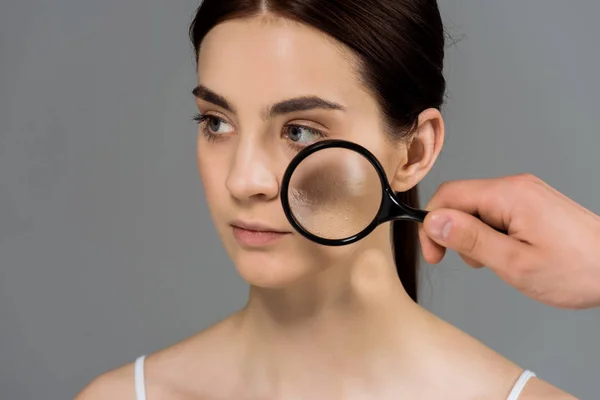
[420,174,600,309]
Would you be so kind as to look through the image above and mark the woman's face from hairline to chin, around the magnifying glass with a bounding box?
[195,17,412,287]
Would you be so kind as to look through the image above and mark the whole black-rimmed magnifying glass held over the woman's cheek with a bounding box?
[281,140,427,246]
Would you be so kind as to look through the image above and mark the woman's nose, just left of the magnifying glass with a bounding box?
[226,141,279,201]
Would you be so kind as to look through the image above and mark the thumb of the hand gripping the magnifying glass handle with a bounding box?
[423,209,527,271]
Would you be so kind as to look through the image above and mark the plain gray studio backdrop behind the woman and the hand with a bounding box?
[0,0,600,400]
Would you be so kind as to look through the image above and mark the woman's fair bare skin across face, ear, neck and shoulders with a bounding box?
[78,16,571,400]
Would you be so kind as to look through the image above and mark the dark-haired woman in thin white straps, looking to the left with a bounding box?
[78,0,572,400]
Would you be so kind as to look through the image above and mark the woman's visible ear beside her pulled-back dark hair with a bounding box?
[390,108,444,192]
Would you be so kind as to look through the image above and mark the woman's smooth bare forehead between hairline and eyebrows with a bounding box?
[198,17,376,109]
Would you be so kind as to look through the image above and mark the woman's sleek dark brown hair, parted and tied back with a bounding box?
[189,0,446,301]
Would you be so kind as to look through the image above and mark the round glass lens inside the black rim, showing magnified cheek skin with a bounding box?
[288,147,383,240]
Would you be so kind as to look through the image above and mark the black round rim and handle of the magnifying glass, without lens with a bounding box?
[280,139,428,246]
